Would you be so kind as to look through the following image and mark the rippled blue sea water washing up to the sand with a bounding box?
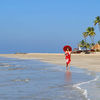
[0,57,100,100]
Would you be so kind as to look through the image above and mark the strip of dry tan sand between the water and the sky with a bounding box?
[0,53,100,72]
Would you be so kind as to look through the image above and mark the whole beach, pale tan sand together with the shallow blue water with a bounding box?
[0,53,100,100]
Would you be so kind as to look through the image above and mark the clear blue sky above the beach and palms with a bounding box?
[0,0,100,53]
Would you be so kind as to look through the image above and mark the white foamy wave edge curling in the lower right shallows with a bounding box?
[73,76,99,100]
